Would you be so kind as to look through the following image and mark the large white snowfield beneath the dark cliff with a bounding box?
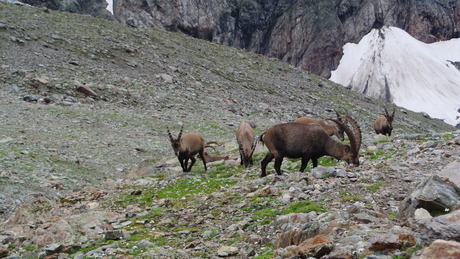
[330,27,460,125]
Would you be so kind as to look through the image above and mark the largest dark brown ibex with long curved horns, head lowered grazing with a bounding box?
[260,115,362,177]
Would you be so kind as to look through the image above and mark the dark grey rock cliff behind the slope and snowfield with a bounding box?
[114,0,460,77]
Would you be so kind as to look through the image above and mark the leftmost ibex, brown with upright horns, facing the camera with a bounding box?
[168,126,207,172]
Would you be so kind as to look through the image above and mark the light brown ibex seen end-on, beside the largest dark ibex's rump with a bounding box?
[236,122,256,167]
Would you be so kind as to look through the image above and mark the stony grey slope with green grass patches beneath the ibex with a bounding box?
[0,3,460,258]
